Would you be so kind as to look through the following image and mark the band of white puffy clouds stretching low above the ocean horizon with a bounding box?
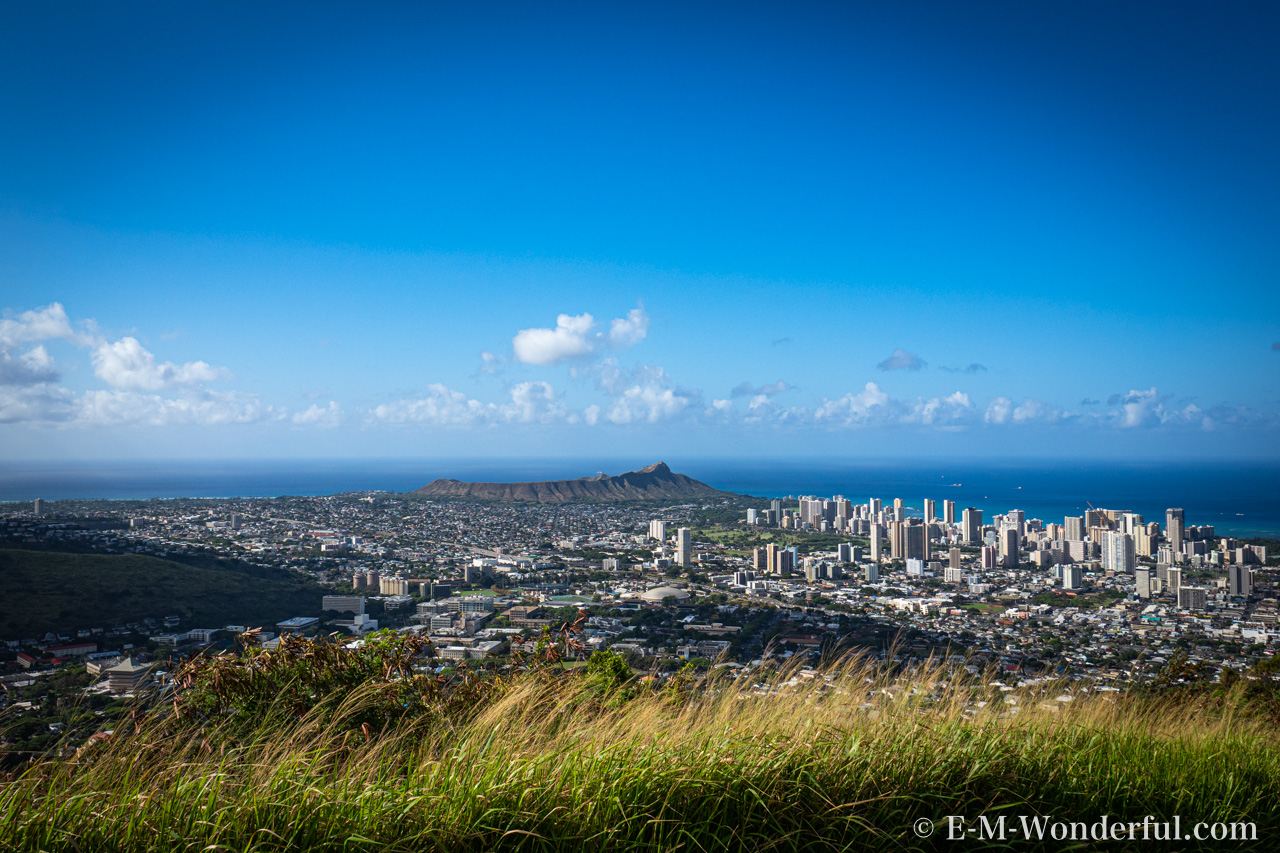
[0,302,1280,458]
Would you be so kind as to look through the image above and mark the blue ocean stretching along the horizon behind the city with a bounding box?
[0,459,1280,537]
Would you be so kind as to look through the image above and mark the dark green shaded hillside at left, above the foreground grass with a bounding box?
[0,548,324,639]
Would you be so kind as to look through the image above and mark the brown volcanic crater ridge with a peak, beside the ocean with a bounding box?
[413,462,732,503]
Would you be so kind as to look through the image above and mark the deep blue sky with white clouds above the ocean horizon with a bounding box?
[0,3,1280,460]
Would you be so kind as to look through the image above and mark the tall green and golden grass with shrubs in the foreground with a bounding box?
[0,633,1280,852]
